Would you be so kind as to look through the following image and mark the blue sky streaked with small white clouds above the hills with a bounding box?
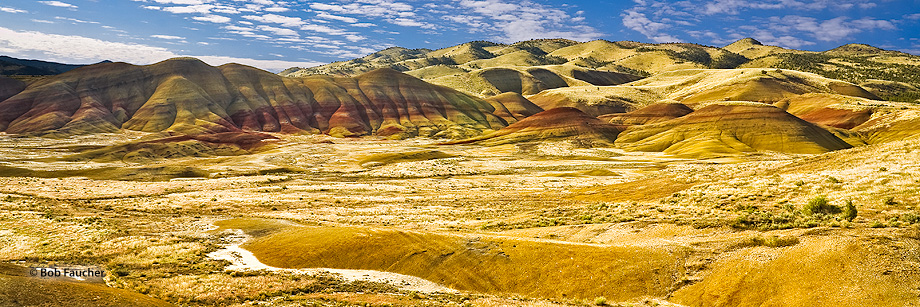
[0,0,920,71]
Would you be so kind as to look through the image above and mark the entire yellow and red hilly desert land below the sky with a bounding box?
[0,39,920,306]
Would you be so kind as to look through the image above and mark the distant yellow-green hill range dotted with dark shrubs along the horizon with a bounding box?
[281,38,920,102]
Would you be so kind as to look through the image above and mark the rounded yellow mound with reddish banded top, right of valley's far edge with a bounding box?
[616,102,851,158]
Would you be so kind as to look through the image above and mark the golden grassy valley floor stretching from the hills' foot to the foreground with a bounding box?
[0,133,920,306]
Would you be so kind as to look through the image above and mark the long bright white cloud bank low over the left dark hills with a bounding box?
[0,27,323,72]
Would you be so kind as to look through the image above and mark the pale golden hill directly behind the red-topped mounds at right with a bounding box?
[529,69,877,116]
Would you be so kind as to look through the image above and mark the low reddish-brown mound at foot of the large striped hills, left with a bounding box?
[65,132,277,163]
